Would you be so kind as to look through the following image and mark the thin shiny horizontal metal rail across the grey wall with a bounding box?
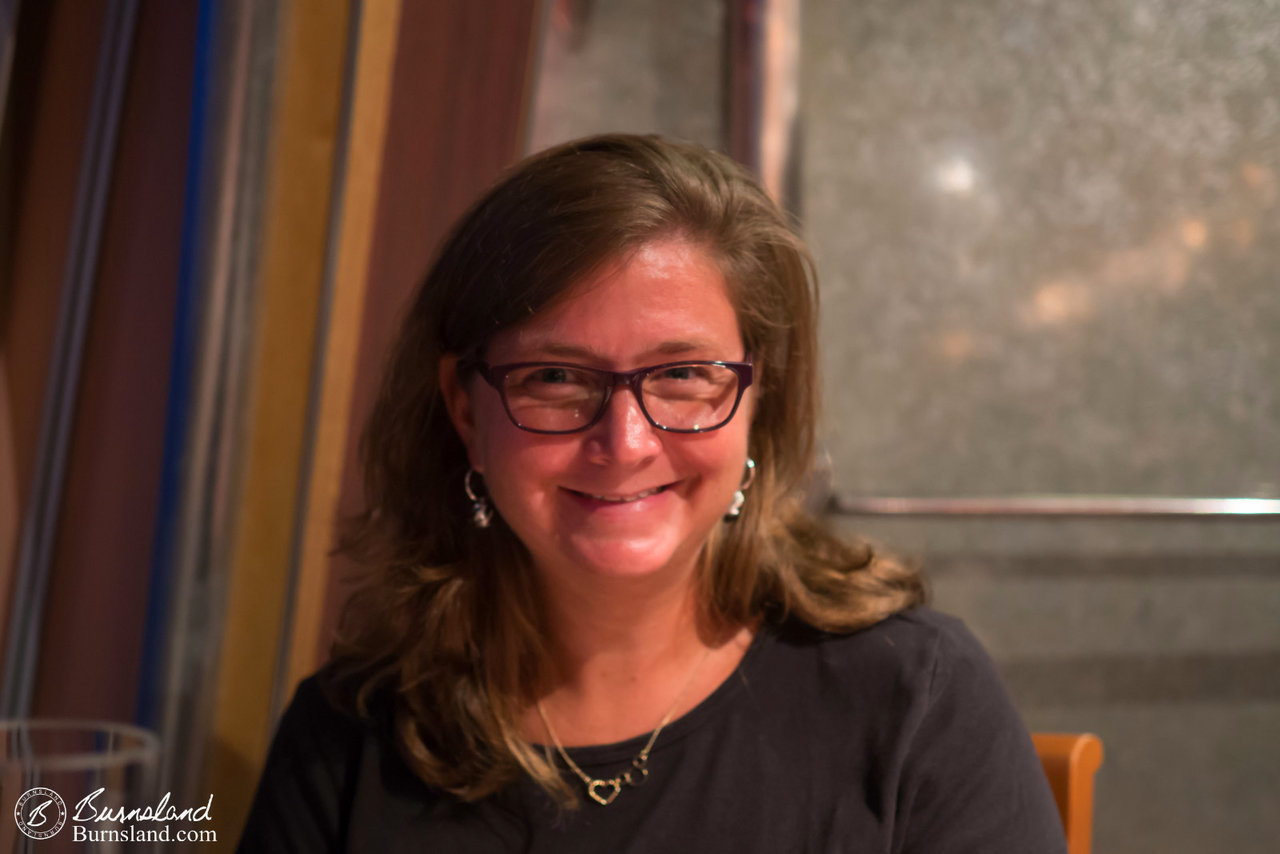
[827,495,1280,520]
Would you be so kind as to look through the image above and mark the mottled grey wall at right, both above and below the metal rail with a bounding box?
[801,0,1280,854]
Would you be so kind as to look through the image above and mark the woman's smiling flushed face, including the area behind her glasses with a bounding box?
[440,237,754,591]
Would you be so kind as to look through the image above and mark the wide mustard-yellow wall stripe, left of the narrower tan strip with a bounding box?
[204,0,355,839]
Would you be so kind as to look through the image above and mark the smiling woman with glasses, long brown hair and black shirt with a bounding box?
[241,136,1062,851]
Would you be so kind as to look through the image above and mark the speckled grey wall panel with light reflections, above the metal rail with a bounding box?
[803,0,1280,497]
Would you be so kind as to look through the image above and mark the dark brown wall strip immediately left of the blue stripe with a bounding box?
[33,3,196,721]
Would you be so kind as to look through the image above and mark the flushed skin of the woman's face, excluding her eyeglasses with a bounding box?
[442,239,754,591]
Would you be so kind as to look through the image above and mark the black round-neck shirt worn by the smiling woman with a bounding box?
[239,608,1066,854]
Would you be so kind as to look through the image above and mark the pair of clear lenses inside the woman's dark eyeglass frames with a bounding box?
[503,365,739,431]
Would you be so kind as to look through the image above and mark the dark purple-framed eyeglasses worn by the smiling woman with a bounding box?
[477,361,751,433]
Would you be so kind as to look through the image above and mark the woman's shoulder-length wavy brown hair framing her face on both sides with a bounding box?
[333,134,924,805]
